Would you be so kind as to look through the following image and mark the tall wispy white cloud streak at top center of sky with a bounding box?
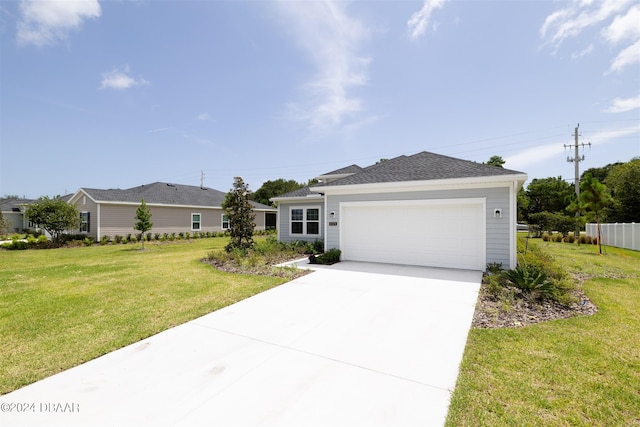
[279,1,370,130]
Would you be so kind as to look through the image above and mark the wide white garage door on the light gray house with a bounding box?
[340,199,486,270]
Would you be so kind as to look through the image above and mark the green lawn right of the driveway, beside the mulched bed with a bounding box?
[446,239,640,427]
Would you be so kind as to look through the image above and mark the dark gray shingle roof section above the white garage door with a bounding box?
[316,151,523,187]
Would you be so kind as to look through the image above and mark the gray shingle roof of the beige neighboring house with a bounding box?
[82,182,273,210]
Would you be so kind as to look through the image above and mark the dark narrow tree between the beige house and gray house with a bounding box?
[222,176,256,252]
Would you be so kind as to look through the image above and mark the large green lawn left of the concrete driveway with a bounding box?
[0,238,286,394]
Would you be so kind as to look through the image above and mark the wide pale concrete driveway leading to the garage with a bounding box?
[0,262,481,427]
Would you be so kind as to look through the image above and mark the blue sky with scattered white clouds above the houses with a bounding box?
[0,0,640,198]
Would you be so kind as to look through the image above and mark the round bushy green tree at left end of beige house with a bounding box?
[25,196,80,242]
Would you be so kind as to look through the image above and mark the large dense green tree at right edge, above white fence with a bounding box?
[605,157,640,222]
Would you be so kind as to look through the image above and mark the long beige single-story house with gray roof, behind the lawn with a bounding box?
[69,182,277,239]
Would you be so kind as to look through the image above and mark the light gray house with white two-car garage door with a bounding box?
[271,152,527,270]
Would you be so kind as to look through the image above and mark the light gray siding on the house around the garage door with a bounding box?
[328,187,512,268]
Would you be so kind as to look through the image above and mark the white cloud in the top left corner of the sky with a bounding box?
[17,0,102,46]
